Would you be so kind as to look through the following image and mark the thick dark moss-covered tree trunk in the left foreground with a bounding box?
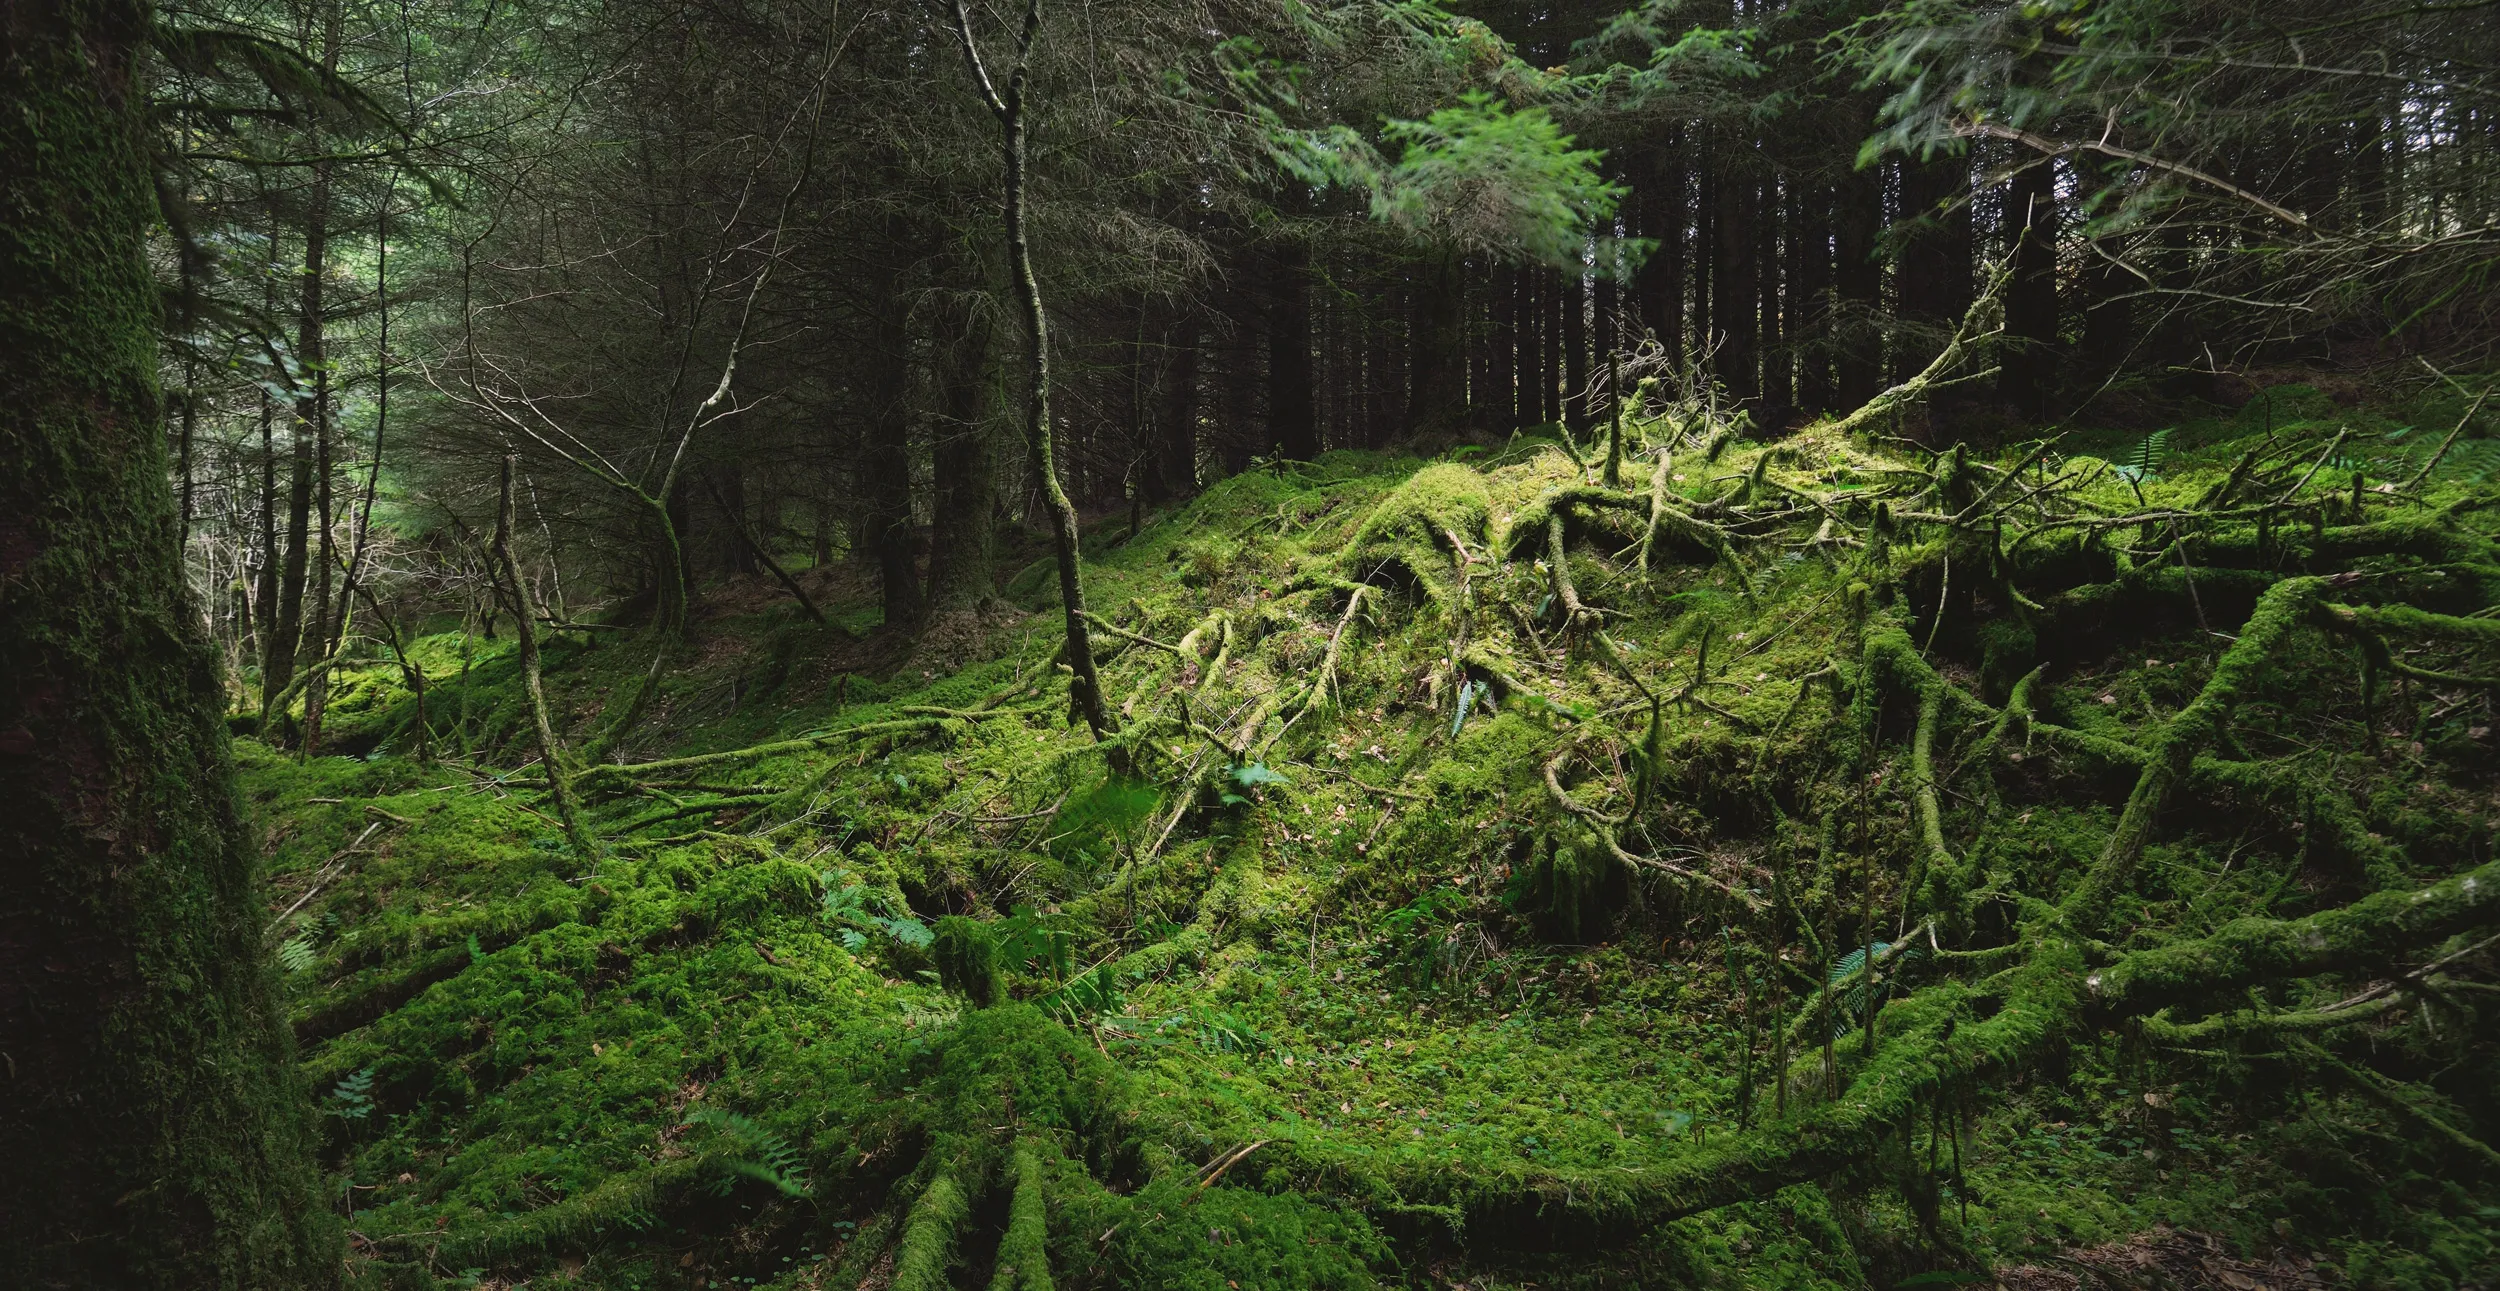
[0,0,340,1288]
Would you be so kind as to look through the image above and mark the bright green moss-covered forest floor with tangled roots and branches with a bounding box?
[238,377,2500,1291]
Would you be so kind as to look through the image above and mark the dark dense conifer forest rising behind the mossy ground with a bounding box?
[163,5,2493,695]
